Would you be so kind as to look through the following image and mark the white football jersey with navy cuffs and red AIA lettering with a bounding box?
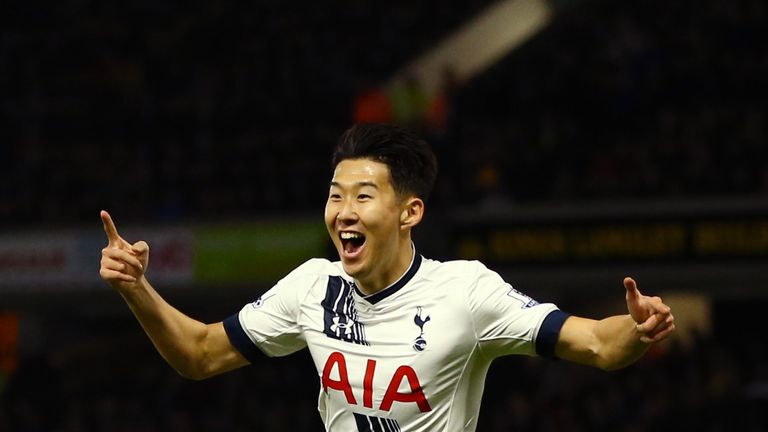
[224,254,567,432]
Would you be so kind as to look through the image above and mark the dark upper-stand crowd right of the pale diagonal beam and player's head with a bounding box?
[448,0,768,208]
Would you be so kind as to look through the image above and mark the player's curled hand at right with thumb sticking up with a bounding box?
[624,278,675,343]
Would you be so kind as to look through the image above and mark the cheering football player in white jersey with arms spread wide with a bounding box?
[101,125,675,431]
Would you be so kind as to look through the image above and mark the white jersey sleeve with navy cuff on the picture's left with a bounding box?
[224,269,318,363]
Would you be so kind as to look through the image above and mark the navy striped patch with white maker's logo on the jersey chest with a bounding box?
[321,276,369,345]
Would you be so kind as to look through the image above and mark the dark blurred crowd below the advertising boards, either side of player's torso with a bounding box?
[0,316,768,432]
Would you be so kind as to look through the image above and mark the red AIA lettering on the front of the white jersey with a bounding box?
[321,351,432,412]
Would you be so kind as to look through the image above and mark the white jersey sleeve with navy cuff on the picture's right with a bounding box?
[468,263,567,357]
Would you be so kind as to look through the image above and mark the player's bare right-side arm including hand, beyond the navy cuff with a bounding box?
[555,278,675,370]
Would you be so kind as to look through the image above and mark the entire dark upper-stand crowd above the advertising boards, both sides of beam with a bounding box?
[0,0,768,225]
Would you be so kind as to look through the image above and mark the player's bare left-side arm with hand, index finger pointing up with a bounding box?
[100,211,248,379]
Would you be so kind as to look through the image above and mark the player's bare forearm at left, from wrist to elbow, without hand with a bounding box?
[118,277,219,379]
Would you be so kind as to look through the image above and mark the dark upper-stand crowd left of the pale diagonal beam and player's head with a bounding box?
[0,0,490,224]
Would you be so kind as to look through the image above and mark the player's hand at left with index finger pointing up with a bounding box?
[99,210,149,289]
